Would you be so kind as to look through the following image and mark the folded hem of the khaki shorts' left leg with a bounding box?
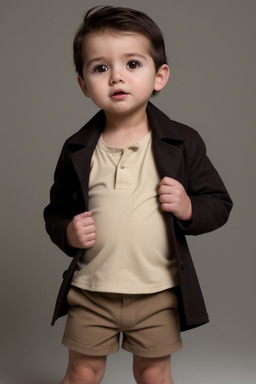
[62,337,119,356]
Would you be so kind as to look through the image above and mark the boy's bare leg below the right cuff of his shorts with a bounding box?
[133,356,173,384]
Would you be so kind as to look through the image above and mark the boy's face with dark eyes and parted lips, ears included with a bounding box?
[78,31,169,115]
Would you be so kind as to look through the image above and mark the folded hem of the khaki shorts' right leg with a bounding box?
[122,339,183,358]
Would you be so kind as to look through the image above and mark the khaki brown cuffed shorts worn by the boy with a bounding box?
[62,287,182,358]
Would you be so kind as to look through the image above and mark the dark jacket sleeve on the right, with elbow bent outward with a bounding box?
[176,132,233,235]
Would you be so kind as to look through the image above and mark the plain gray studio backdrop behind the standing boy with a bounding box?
[0,0,256,384]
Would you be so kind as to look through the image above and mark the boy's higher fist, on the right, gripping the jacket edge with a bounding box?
[158,177,192,221]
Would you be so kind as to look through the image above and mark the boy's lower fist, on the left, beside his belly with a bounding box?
[66,212,96,249]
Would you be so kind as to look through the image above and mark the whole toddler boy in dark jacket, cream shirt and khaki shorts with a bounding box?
[44,6,232,384]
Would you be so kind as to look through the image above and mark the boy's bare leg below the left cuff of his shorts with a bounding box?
[62,351,106,384]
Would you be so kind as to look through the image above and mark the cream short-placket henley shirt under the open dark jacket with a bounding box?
[72,132,179,294]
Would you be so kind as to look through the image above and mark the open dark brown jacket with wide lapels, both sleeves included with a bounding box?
[44,103,232,331]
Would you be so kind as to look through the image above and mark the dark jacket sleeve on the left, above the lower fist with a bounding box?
[44,144,78,256]
